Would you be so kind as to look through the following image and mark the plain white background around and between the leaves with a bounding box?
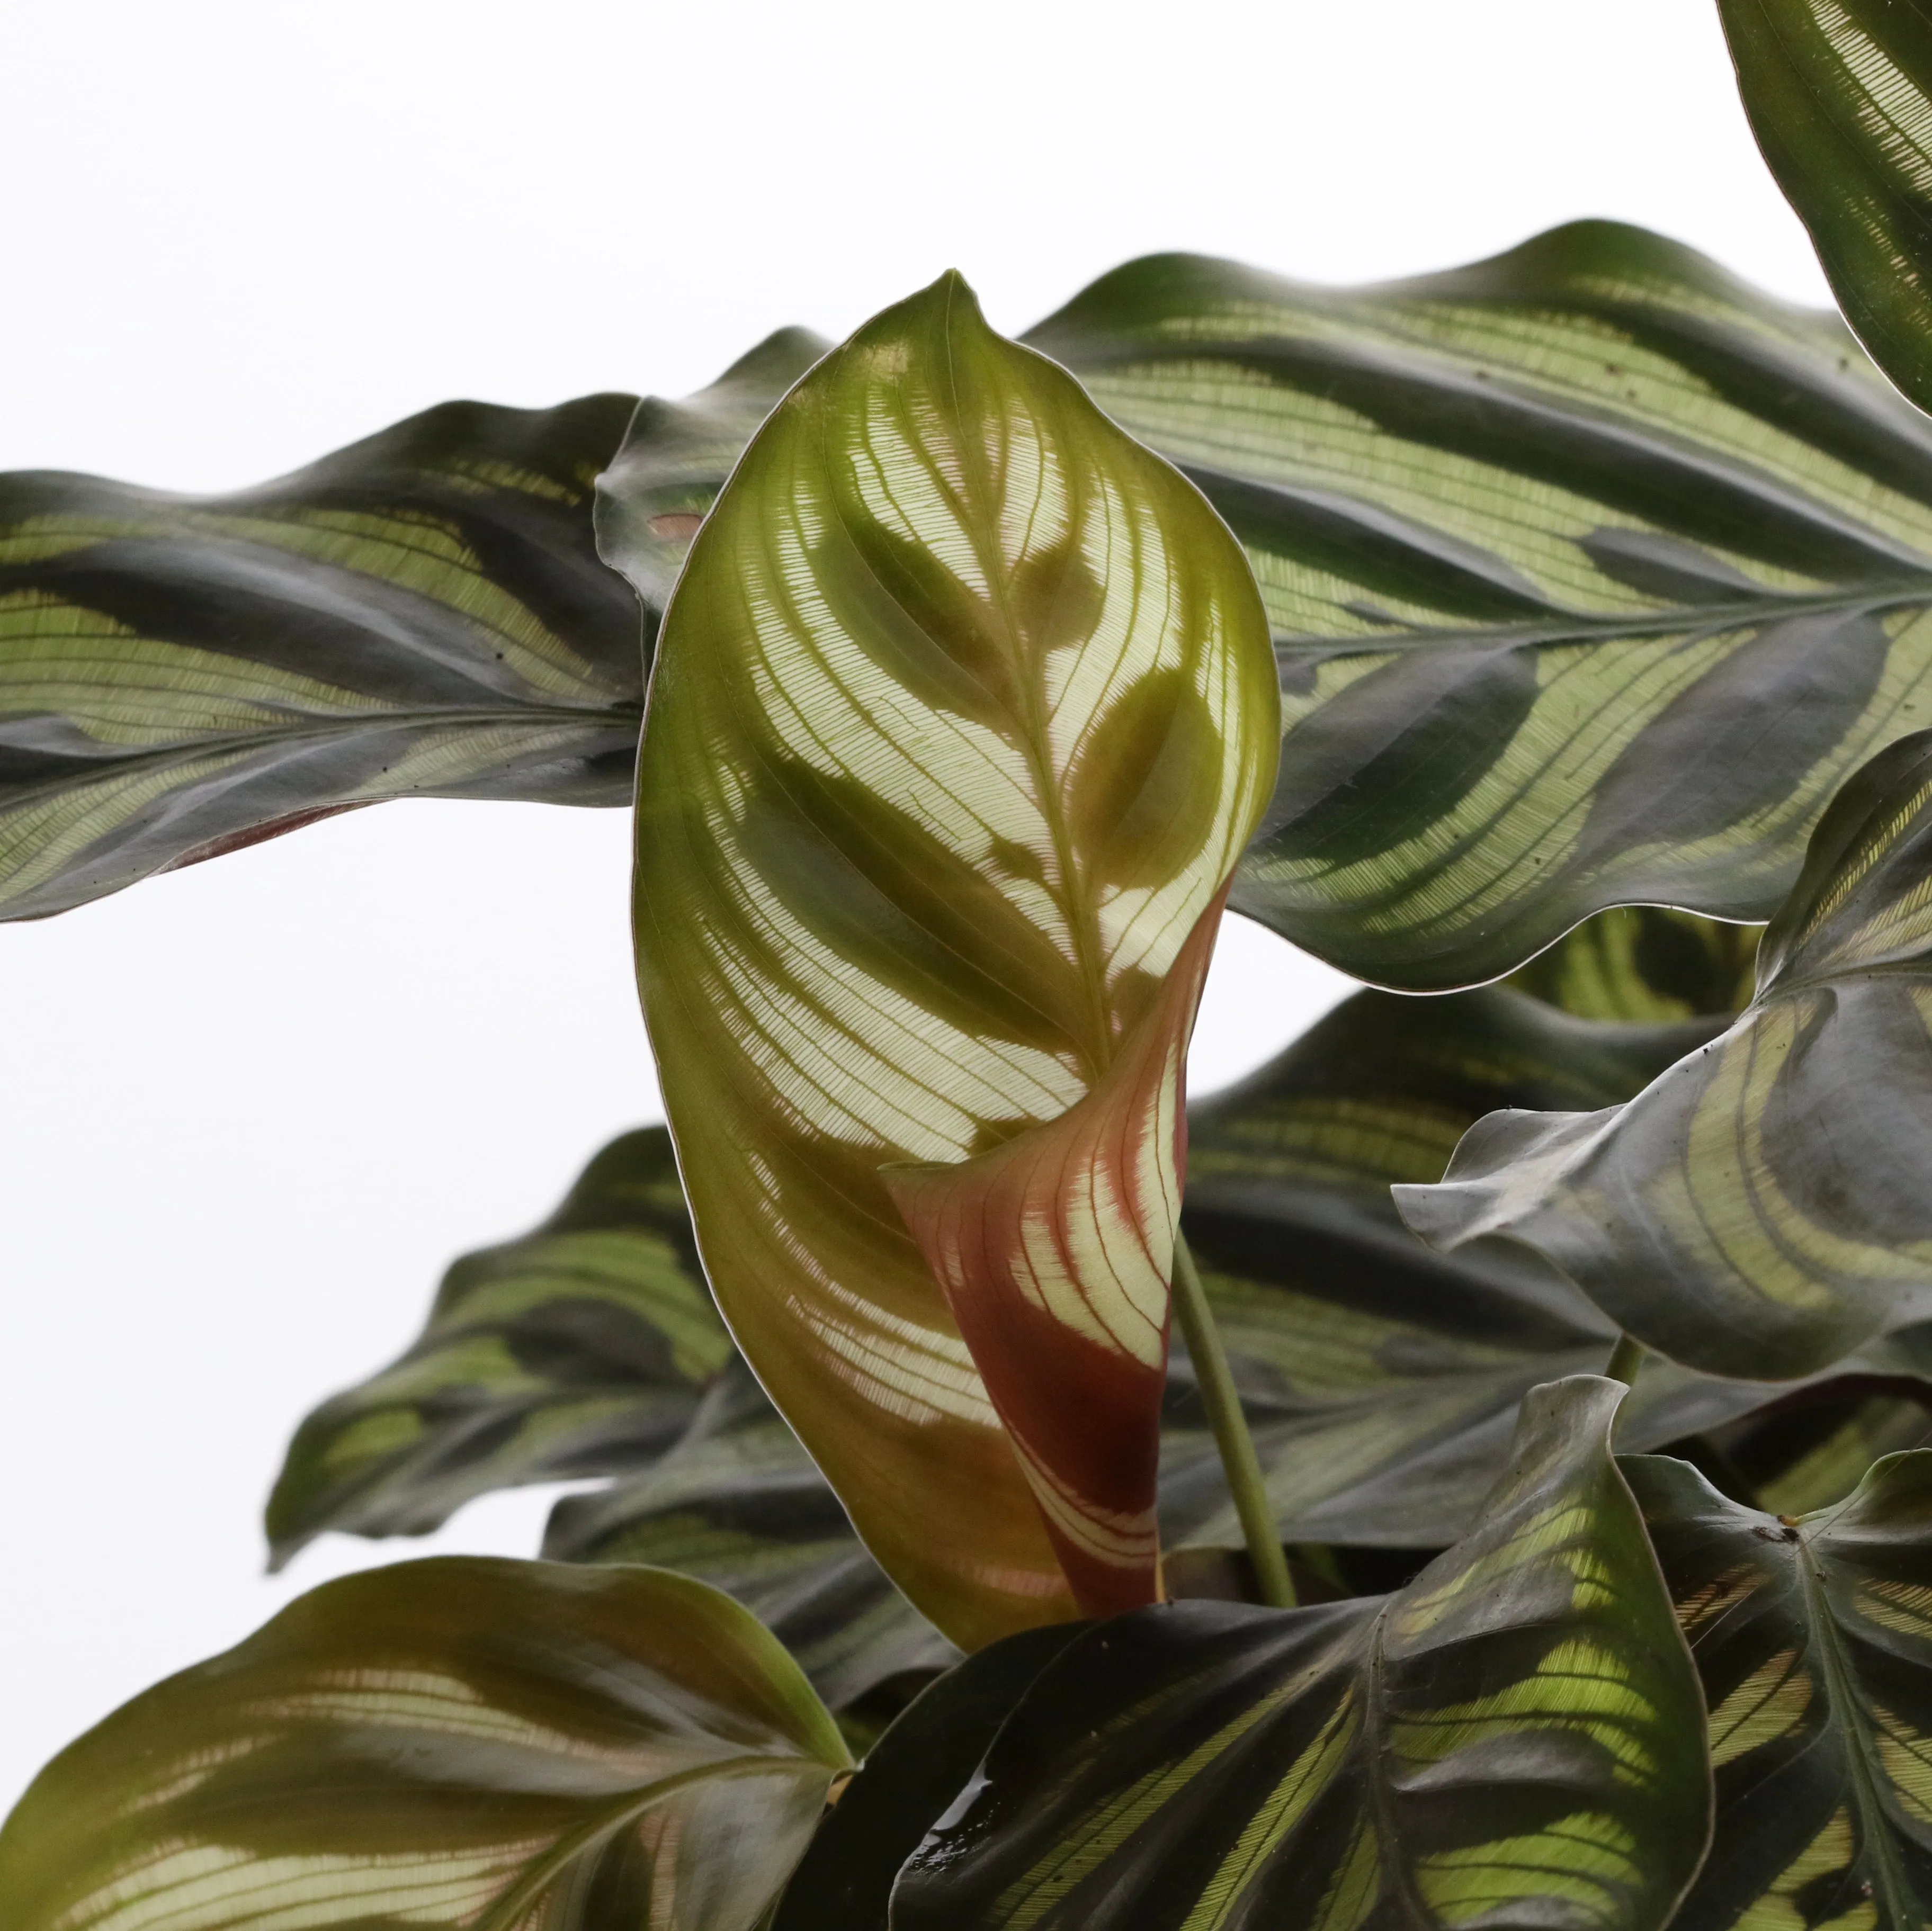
[0,0,1824,1803]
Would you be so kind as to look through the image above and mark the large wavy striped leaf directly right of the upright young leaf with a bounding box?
[1026,222,1932,991]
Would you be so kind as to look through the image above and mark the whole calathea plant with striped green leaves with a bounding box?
[22,0,1932,1931]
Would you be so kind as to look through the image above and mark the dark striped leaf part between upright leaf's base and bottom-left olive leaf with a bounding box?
[543,1361,958,1709]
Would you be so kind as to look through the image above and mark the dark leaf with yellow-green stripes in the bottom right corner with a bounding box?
[1623,1452,1932,1931]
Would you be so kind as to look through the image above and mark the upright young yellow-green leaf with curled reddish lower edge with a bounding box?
[612,276,1279,1647]
